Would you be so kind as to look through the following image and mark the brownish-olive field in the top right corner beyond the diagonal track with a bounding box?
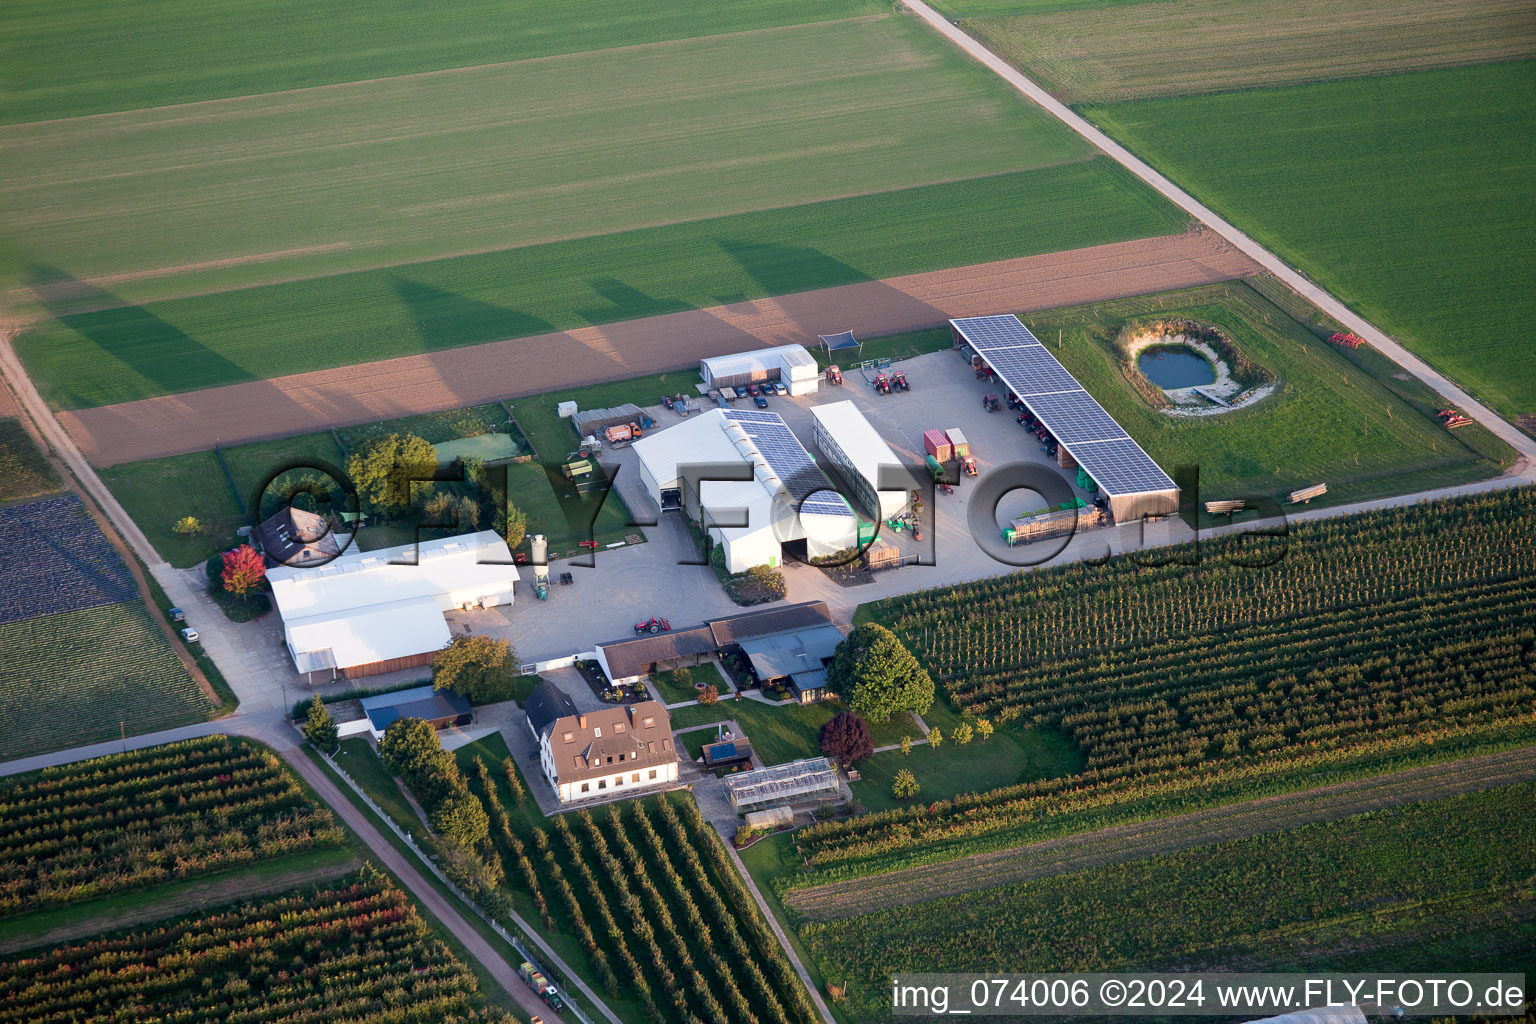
[952,0,1536,103]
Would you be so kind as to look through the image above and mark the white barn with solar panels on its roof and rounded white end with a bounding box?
[634,408,859,573]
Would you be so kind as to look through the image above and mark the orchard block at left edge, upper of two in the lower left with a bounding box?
[0,735,344,915]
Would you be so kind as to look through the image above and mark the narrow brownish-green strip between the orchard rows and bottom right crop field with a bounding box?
[783,746,1536,921]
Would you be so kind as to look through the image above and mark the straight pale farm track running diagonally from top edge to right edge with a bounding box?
[902,0,1536,459]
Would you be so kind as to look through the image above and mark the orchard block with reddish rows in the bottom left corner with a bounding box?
[0,867,513,1024]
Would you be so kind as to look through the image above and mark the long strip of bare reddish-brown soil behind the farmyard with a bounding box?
[58,230,1255,467]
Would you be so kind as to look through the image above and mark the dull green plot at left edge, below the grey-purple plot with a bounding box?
[0,600,212,760]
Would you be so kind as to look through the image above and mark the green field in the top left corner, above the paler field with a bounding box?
[0,0,880,124]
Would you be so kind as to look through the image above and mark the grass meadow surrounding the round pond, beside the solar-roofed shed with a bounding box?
[1025,282,1513,504]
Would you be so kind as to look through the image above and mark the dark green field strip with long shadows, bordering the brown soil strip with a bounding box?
[15,158,1186,407]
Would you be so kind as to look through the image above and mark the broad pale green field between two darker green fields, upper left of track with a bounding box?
[0,17,1091,315]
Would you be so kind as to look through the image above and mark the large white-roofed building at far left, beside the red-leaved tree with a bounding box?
[267,530,518,679]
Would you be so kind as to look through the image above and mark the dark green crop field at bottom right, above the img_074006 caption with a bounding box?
[800,783,1536,1021]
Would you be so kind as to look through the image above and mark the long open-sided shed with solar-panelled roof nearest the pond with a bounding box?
[949,315,1178,522]
